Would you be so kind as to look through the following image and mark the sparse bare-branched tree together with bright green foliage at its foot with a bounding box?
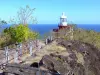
[4,6,39,45]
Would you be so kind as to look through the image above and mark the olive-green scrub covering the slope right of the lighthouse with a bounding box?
[74,29,100,48]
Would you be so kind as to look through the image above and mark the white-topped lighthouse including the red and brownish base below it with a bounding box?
[52,12,73,40]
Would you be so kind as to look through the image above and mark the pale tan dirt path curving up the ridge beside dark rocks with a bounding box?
[24,41,67,64]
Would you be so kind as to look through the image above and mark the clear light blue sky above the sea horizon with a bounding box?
[0,0,100,24]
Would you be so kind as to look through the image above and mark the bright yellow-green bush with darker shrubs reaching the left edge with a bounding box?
[0,24,39,47]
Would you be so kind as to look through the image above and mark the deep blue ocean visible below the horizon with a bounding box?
[2,24,100,35]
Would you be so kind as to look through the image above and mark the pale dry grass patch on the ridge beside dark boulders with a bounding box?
[29,41,67,62]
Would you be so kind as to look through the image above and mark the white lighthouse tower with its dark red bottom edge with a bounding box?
[58,12,67,29]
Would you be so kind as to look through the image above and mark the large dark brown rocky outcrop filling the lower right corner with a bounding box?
[40,40,100,75]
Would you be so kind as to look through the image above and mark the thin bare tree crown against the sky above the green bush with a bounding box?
[10,5,37,25]
